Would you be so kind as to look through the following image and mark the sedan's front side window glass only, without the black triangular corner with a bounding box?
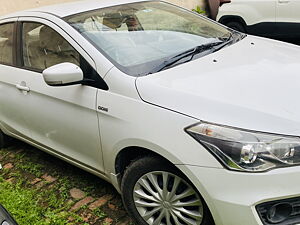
[22,23,80,71]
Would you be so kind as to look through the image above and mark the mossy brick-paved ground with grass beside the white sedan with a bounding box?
[0,141,133,225]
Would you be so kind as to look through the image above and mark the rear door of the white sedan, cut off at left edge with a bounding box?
[0,18,31,139]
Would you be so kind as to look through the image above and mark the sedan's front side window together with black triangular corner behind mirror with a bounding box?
[22,22,108,90]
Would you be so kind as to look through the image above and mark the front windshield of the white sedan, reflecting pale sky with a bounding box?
[65,1,237,76]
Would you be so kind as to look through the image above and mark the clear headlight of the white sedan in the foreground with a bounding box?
[186,123,300,172]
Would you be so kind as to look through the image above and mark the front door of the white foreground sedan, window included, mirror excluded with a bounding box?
[18,17,103,173]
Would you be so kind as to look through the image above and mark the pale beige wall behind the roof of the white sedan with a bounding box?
[0,0,202,15]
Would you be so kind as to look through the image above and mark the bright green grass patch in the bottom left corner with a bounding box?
[0,177,89,225]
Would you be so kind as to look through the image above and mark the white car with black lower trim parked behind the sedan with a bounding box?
[217,0,300,38]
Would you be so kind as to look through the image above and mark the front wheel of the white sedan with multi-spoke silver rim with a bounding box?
[121,156,214,225]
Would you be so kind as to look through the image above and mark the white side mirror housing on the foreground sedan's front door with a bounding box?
[42,63,83,86]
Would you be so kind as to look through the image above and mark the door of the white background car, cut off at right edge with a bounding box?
[276,0,300,38]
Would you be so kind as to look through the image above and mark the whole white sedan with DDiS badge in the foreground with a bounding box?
[0,0,300,225]
